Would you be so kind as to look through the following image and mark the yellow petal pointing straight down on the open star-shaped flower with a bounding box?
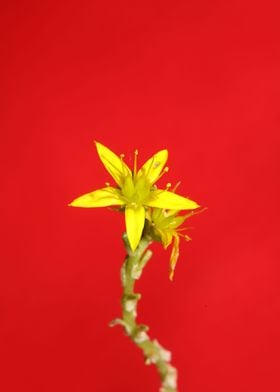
[125,206,145,252]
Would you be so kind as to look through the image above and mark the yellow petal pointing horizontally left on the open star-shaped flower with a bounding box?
[69,187,125,208]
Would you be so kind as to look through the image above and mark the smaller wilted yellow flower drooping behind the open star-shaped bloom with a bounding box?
[147,208,203,280]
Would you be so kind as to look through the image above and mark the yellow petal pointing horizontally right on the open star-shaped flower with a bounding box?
[145,189,199,210]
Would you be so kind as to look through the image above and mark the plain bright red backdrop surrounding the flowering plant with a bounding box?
[0,1,280,392]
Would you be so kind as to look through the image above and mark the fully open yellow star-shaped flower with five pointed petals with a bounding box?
[69,142,199,251]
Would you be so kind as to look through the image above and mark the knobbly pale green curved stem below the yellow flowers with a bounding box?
[111,234,178,392]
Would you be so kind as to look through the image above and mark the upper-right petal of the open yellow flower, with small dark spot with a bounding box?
[137,150,168,184]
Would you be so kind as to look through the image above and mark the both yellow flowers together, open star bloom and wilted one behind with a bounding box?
[69,142,199,279]
